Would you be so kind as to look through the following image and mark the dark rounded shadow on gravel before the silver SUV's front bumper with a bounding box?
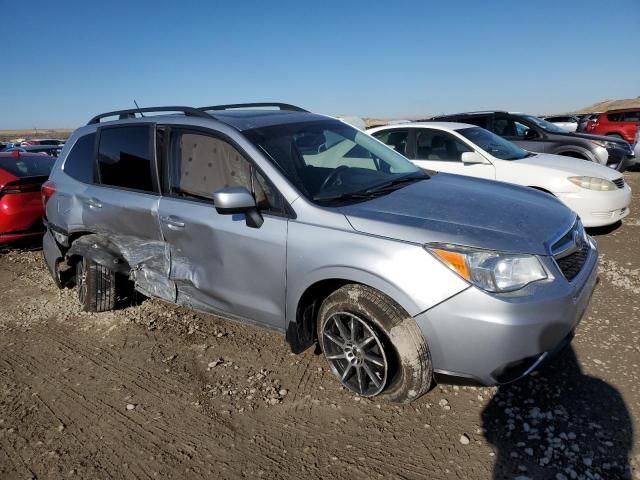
[482,347,633,480]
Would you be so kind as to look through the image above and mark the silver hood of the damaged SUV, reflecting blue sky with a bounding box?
[340,173,576,255]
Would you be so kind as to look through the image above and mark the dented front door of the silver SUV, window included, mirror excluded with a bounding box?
[160,127,288,329]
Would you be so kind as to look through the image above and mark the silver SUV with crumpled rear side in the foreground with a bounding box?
[42,103,597,401]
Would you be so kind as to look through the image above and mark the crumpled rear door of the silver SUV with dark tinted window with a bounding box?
[78,123,176,301]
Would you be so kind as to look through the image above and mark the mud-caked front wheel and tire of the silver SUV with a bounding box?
[318,284,433,403]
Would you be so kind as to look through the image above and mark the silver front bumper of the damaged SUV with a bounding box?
[415,238,598,385]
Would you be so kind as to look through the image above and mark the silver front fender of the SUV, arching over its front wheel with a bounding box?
[285,222,469,328]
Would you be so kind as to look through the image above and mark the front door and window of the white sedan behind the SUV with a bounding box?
[412,128,496,179]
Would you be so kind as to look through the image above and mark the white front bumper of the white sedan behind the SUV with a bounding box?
[556,184,631,227]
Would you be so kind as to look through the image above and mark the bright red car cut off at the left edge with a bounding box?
[0,152,56,244]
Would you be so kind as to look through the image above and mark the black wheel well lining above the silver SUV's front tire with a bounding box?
[286,278,356,353]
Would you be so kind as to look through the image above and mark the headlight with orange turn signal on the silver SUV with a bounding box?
[426,245,547,292]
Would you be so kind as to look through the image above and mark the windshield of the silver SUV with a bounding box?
[244,120,428,202]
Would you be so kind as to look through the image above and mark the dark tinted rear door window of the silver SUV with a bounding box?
[98,125,154,192]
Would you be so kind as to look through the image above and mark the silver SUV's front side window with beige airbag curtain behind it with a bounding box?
[169,131,284,212]
